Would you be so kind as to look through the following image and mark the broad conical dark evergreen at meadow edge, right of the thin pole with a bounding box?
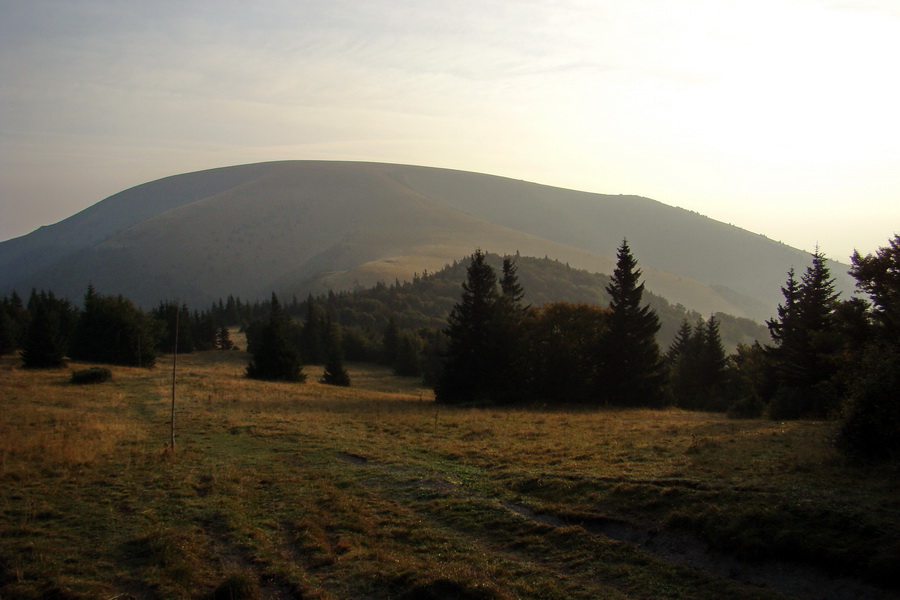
[247,293,306,382]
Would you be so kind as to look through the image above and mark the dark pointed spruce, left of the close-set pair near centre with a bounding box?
[435,249,499,404]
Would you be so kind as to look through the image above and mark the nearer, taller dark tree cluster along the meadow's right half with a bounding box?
[435,236,900,459]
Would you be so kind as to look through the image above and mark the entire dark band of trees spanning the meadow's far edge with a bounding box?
[0,236,900,456]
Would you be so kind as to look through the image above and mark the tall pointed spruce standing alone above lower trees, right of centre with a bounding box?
[597,240,665,406]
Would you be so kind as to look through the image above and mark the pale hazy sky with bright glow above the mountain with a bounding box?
[0,0,900,261]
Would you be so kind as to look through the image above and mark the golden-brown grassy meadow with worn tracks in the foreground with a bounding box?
[0,352,900,600]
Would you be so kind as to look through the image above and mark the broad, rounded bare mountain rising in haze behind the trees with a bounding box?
[0,161,852,320]
